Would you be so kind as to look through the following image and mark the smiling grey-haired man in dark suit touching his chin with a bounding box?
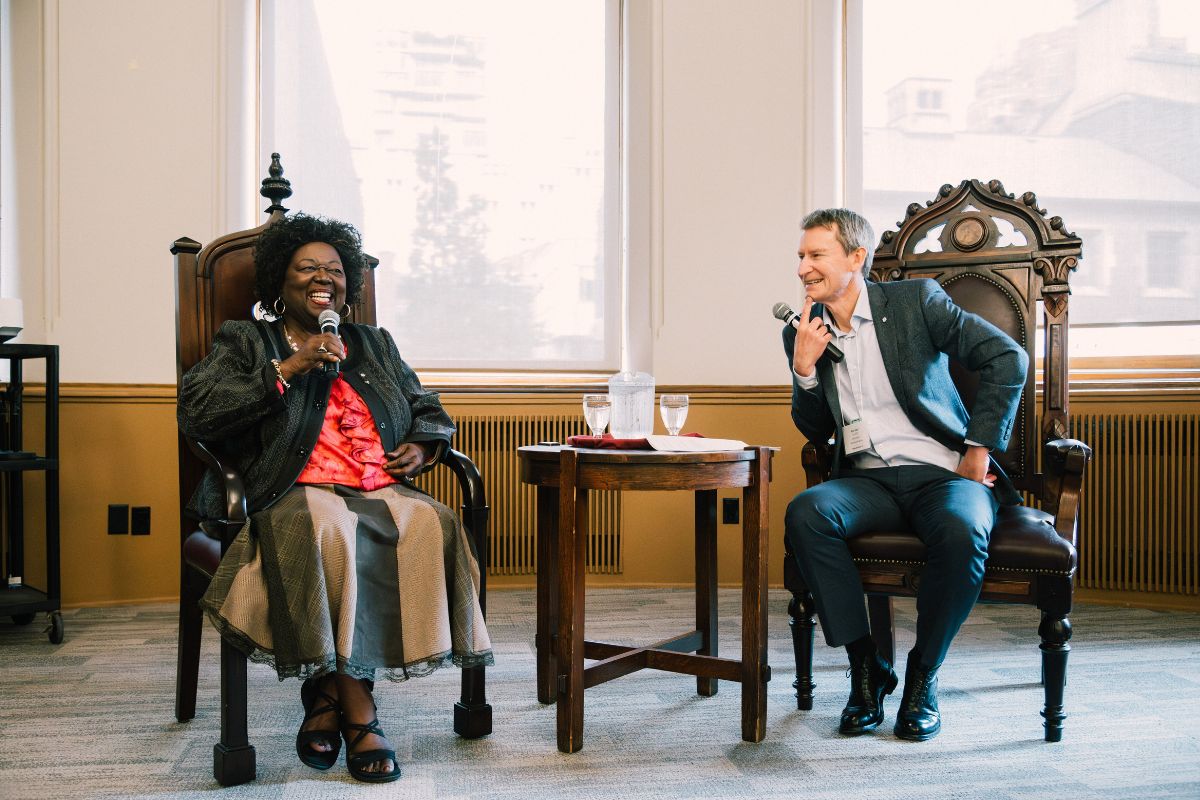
[784,209,1028,741]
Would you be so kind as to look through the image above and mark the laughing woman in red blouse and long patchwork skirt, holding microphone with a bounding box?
[179,213,492,782]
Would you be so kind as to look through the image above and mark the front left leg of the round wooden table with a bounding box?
[558,449,588,753]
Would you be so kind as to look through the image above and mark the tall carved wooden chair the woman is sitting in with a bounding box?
[170,154,492,786]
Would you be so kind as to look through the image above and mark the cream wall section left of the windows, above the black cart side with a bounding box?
[12,0,221,383]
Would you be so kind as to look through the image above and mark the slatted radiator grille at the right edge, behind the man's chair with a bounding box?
[1070,414,1200,595]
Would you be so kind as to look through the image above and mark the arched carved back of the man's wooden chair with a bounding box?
[871,180,1082,497]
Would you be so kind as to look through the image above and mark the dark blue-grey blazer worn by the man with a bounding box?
[784,278,1028,505]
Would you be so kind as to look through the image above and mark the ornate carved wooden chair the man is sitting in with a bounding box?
[784,180,1092,741]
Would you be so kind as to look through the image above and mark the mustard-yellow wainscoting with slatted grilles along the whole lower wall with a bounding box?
[4,385,1200,609]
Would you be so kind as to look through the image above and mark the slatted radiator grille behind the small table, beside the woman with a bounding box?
[418,414,623,575]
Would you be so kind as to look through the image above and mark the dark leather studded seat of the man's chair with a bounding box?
[850,506,1079,575]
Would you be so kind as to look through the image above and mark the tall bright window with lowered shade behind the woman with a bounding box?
[260,0,620,371]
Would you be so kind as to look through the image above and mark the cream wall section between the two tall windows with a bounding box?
[652,0,805,385]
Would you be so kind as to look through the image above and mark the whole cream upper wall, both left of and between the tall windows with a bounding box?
[5,0,829,385]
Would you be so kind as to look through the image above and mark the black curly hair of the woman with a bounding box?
[254,212,367,311]
